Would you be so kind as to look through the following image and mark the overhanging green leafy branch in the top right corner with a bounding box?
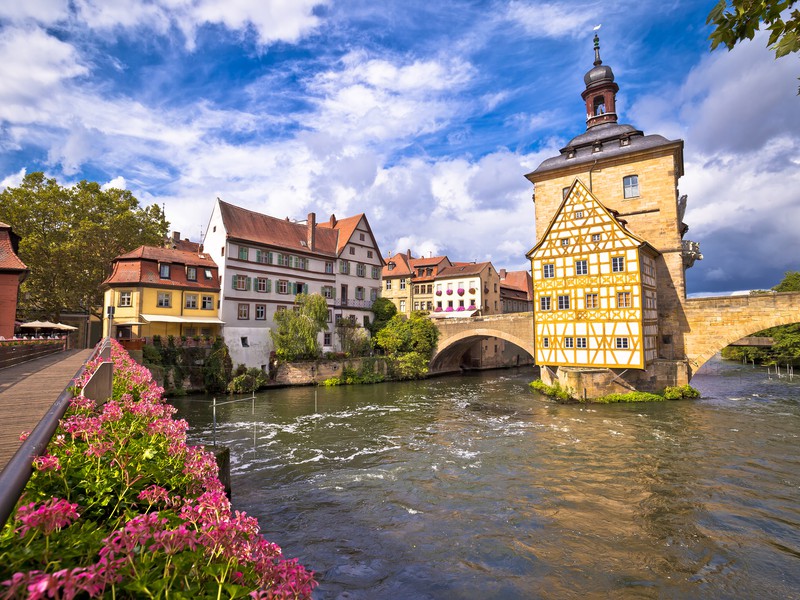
[706,0,800,94]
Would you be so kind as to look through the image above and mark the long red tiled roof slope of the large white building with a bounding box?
[219,200,338,256]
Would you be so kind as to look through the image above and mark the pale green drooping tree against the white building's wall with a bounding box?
[270,294,328,362]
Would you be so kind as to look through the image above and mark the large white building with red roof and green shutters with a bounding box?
[203,199,383,368]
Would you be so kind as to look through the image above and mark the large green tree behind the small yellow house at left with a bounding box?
[0,172,169,320]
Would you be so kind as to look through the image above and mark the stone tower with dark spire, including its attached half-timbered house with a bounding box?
[526,36,702,390]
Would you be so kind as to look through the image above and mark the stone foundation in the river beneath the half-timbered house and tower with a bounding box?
[541,360,689,400]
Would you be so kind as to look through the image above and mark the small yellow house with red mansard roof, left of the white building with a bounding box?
[103,246,223,339]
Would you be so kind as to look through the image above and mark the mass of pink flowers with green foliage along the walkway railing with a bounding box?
[0,340,316,599]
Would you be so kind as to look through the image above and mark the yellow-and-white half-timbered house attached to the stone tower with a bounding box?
[528,179,658,369]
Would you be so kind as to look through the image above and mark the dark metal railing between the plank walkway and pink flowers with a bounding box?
[0,338,110,528]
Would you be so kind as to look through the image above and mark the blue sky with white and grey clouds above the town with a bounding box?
[0,0,800,295]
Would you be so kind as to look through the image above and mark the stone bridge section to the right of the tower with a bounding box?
[685,292,800,374]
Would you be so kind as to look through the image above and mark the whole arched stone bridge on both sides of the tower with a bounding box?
[431,292,800,377]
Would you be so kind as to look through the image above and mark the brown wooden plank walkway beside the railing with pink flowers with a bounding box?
[0,348,92,470]
